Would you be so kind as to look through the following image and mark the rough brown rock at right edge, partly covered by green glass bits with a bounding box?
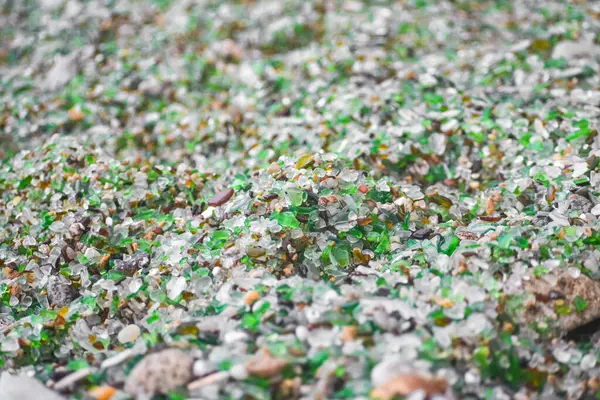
[524,272,600,335]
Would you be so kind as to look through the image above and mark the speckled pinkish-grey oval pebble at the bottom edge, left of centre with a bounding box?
[125,349,194,396]
